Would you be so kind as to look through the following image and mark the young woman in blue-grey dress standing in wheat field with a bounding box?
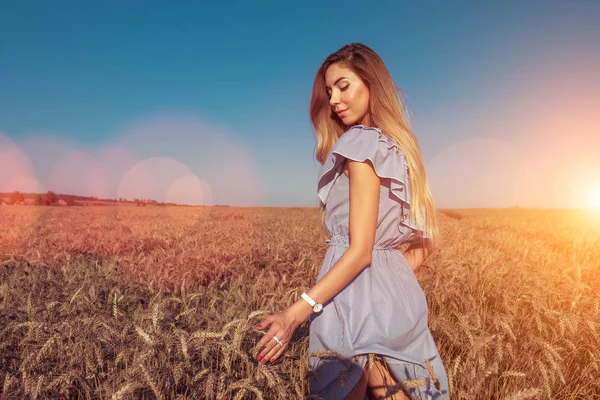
[257,43,448,399]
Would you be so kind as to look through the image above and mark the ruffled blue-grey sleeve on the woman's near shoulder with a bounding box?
[317,125,426,234]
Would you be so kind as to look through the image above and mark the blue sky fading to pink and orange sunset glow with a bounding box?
[0,0,600,208]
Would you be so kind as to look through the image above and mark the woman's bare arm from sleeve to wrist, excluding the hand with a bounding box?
[288,160,381,323]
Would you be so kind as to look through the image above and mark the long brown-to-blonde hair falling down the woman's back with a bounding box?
[309,43,439,248]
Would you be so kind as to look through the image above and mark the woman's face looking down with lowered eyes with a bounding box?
[325,63,370,126]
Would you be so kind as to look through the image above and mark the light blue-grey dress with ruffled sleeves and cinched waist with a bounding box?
[308,125,448,400]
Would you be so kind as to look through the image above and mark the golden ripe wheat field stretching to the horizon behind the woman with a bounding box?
[0,206,600,400]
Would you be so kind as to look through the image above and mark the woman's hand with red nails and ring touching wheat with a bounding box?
[255,308,299,364]
